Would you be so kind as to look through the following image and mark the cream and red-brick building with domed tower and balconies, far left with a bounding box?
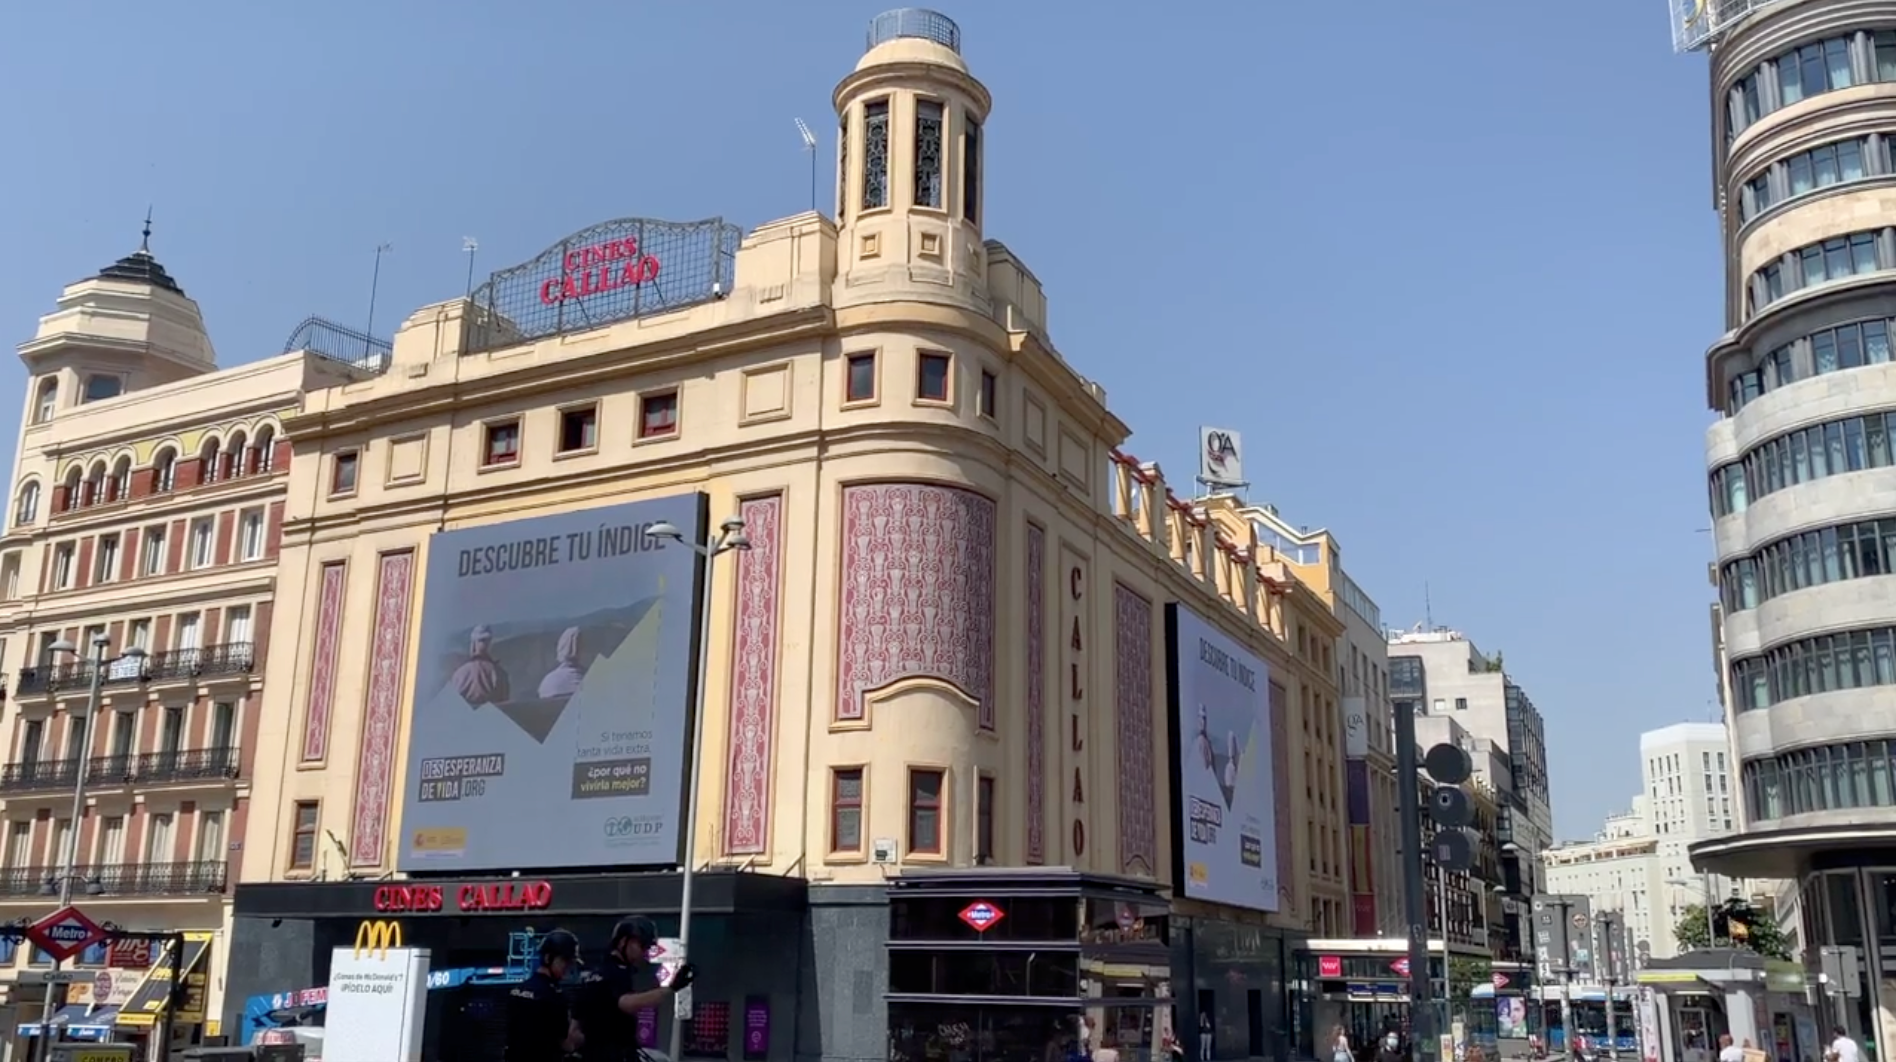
[0,247,377,1039]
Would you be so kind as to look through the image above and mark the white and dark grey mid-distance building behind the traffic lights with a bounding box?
[1390,628,1553,954]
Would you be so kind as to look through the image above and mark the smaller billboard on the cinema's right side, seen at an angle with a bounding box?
[1166,603,1278,910]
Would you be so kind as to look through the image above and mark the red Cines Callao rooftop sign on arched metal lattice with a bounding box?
[472,218,741,347]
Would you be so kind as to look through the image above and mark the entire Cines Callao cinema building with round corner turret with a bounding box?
[211,9,1348,1058]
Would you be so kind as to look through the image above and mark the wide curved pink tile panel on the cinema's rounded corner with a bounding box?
[836,484,995,730]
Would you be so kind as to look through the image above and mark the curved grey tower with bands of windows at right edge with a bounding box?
[1676,0,1896,1041]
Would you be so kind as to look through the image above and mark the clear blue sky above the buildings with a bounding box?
[0,0,1722,836]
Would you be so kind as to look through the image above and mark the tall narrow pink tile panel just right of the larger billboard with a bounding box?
[724,495,783,855]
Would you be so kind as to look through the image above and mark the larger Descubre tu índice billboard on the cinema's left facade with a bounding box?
[396,493,705,870]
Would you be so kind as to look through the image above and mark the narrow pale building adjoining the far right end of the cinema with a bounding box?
[1240,504,1407,937]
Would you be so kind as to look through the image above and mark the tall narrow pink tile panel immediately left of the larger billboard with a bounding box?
[349,550,415,867]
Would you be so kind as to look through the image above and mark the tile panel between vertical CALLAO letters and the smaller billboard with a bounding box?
[1113,582,1158,876]
